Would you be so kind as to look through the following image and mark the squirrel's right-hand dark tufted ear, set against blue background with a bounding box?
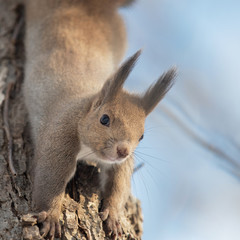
[141,68,176,115]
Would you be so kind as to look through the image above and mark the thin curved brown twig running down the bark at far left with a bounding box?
[3,82,17,176]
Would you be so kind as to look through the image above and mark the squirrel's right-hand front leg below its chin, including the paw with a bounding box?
[100,156,134,238]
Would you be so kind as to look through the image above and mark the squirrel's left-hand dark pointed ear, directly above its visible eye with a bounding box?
[98,50,141,105]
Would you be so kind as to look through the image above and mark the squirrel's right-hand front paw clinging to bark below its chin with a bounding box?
[99,208,122,239]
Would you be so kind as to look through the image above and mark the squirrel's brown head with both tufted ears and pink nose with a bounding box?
[79,51,176,163]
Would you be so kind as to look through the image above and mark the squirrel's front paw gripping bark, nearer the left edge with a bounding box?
[35,211,61,240]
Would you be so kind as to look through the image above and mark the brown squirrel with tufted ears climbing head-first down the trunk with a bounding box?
[23,0,176,239]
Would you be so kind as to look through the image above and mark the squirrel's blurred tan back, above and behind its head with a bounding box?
[24,0,130,136]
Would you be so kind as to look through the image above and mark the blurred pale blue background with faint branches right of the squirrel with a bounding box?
[121,0,240,240]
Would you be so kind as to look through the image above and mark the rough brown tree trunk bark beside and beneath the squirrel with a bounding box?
[0,0,143,239]
